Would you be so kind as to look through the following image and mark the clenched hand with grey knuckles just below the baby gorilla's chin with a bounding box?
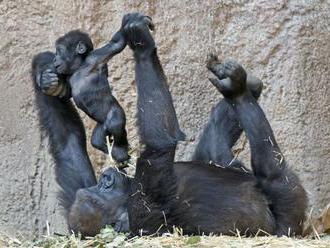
[37,69,63,96]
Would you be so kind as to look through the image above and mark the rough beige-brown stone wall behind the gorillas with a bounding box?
[0,0,330,235]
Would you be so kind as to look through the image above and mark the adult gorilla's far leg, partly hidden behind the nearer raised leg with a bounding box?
[192,55,262,167]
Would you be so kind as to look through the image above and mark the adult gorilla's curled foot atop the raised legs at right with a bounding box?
[207,55,247,99]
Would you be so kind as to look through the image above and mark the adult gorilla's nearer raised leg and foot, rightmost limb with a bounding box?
[210,61,307,235]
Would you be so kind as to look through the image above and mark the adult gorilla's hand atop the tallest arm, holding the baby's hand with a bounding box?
[122,13,155,52]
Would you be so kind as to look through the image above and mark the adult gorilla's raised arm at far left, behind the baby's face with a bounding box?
[32,52,96,214]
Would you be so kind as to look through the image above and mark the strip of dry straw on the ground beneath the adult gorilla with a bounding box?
[0,228,330,248]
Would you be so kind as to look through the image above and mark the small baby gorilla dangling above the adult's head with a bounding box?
[43,30,128,162]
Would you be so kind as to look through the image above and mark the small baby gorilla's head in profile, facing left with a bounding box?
[54,30,93,75]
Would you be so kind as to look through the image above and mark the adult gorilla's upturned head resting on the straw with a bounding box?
[68,168,130,236]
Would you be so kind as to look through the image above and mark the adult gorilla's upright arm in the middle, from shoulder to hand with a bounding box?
[123,13,184,234]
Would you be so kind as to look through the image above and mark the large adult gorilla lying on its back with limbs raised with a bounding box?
[33,13,307,236]
